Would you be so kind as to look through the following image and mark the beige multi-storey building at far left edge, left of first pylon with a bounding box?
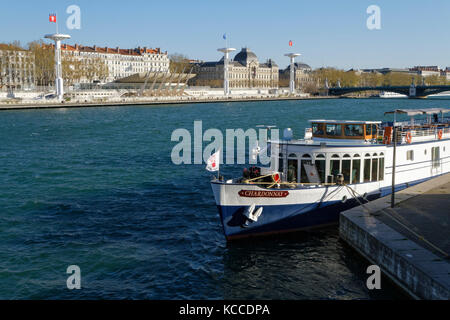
[0,45,35,90]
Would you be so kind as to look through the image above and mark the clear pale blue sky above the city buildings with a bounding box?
[0,0,450,69]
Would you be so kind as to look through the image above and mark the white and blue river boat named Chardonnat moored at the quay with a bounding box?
[211,108,450,240]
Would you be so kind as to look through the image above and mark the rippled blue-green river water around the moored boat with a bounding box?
[0,99,449,299]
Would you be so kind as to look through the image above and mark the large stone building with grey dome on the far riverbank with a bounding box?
[191,48,279,89]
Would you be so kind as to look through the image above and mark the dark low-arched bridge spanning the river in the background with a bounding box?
[328,85,450,98]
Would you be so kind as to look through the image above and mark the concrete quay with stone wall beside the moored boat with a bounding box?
[339,173,450,300]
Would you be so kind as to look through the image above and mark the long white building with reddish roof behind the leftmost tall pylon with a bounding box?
[54,44,170,83]
